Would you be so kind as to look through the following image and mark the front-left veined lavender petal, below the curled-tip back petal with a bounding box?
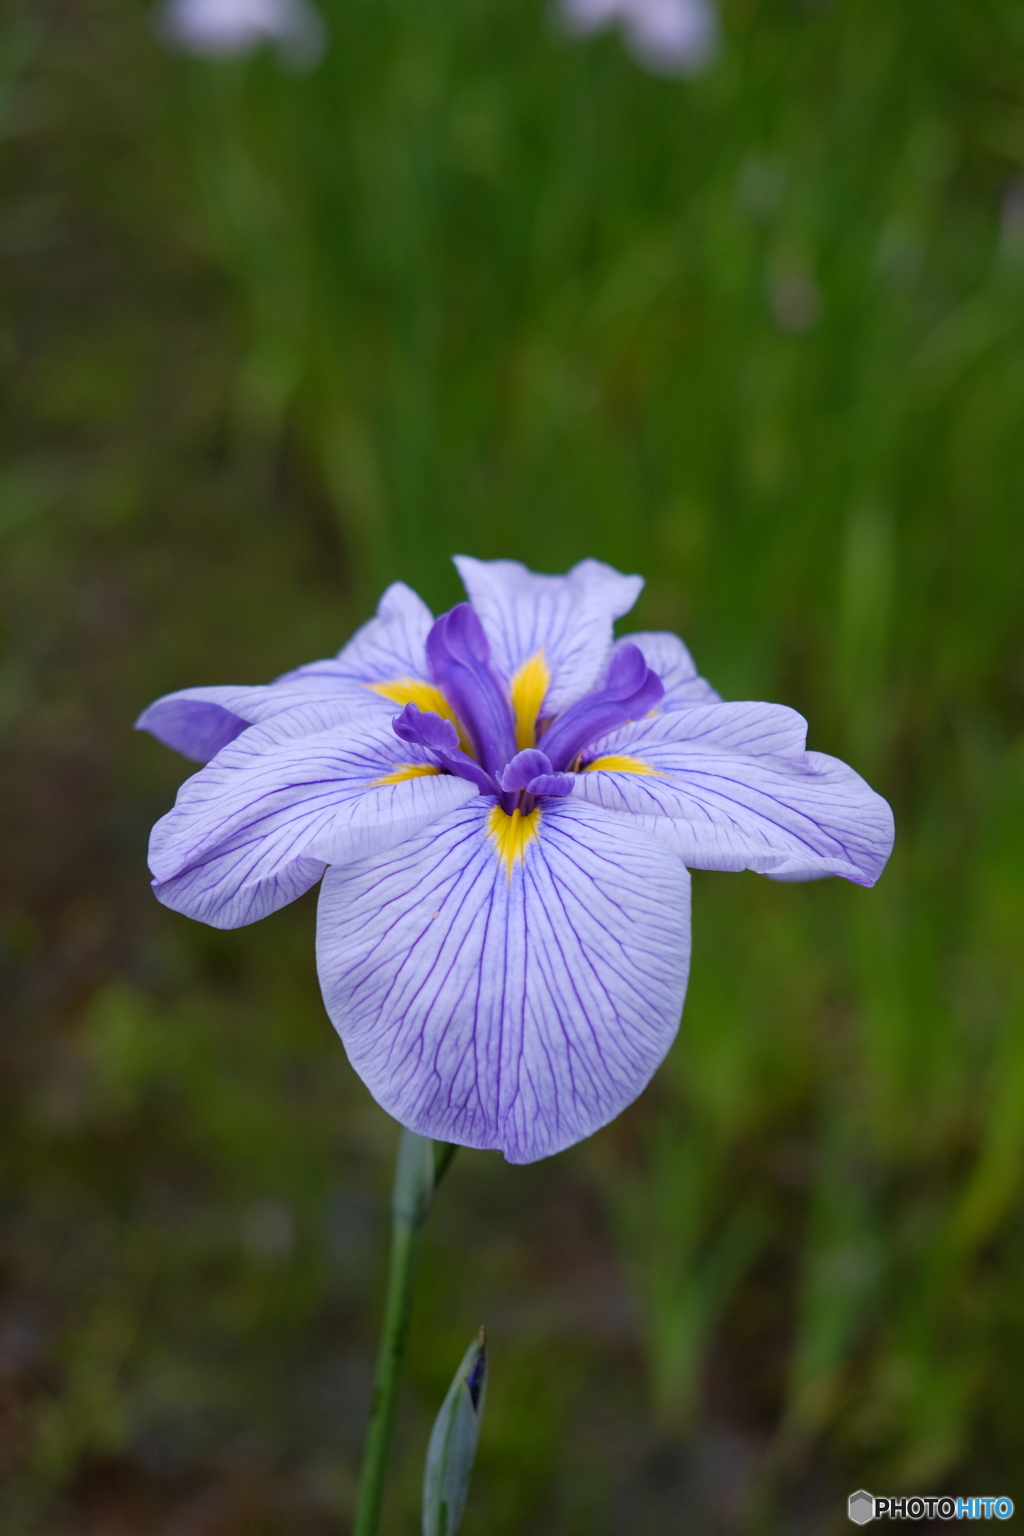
[149,716,477,928]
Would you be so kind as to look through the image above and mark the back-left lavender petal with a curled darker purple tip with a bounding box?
[135,582,433,763]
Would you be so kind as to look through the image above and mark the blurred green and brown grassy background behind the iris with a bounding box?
[0,0,1024,1536]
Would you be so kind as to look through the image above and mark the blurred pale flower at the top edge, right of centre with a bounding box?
[560,0,718,75]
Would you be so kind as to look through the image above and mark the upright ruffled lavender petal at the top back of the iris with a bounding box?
[454,554,643,714]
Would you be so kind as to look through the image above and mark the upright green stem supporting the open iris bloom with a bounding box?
[352,1130,456,1536]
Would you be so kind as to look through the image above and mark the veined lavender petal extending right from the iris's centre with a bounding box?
[574,703,894,885]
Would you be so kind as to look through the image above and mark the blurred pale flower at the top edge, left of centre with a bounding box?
[160,0,324,68]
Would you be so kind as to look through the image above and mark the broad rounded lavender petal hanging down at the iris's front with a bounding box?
[318,797,689,1163]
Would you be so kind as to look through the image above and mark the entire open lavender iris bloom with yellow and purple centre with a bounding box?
[138,558,892,1163]
